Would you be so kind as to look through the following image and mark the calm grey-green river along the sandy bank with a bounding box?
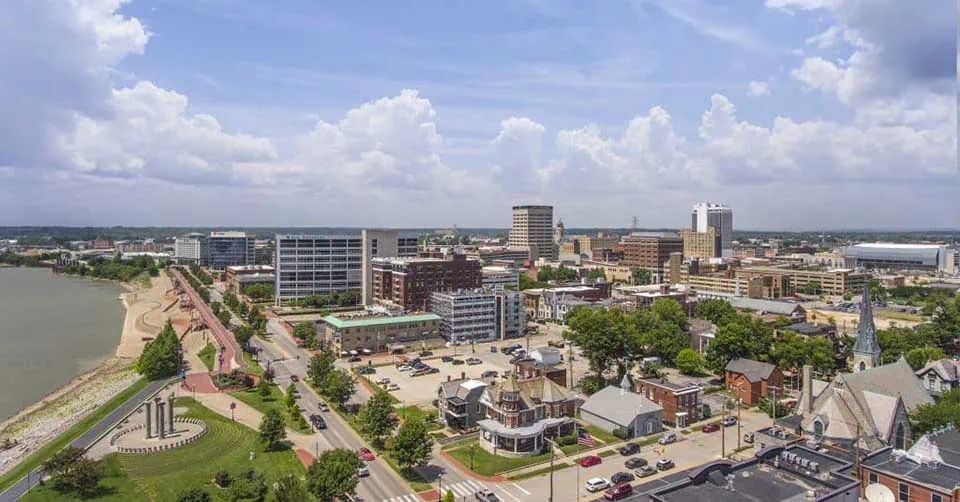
[0,268,125,421]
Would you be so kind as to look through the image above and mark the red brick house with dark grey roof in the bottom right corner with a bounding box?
[860,426,960,502]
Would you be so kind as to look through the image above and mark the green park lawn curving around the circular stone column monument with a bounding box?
[21,398,306,502]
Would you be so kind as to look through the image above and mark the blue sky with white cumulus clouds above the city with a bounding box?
[0,0,960,230]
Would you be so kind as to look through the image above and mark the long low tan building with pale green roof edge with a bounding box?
[323,312,444,355]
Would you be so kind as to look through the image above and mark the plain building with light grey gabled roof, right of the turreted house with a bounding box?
[580,375,663,437]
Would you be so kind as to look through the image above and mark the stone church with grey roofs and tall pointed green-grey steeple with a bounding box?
[779,285,933,451]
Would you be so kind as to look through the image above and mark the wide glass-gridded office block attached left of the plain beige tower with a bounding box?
[274,234,363,303]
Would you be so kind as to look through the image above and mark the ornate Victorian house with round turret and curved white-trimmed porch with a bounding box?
[477,373,577,457]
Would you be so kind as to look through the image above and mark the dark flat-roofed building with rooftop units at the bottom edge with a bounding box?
[644,446,860,502]
